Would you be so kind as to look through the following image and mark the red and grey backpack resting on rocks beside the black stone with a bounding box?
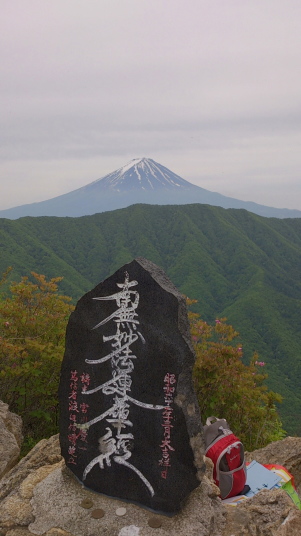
[204,417,247,499]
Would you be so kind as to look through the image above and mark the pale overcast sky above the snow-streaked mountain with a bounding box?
[0,0,301,210]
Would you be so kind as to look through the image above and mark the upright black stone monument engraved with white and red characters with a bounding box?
[59,258,203,514]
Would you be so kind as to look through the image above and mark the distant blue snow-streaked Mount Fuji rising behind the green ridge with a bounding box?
[0,158,301,220]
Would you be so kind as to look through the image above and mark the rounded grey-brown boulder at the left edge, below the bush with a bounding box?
[0,400,23,478]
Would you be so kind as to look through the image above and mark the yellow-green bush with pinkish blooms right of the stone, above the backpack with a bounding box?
[188,300,285,450]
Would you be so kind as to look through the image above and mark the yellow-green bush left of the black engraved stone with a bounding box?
[0,272,73,446]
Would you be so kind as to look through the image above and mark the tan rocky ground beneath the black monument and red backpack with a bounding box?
[0,403,301,536]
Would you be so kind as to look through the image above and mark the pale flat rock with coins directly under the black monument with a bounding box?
[28,460,224,536]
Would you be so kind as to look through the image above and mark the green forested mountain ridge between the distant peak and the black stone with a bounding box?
[0,204,301,435]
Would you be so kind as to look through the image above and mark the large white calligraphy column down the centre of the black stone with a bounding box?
[81,272,164,496]
